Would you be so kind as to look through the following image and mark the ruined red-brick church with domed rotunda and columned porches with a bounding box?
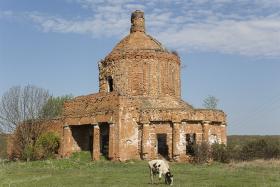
[52,10,227,161]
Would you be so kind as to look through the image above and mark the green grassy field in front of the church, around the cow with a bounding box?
[0,154,280,187]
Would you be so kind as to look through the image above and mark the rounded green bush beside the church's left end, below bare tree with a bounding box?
[35,132,59,159]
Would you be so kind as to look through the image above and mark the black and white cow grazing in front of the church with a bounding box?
[148,160,173,185]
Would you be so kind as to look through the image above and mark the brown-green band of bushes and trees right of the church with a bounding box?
[191,136,280,164]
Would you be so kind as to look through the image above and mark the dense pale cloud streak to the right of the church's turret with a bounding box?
[156,18,280,57]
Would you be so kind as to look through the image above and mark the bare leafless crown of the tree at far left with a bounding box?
[0,85,50,132]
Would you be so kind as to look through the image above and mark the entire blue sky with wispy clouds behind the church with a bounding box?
[0,0,280,134]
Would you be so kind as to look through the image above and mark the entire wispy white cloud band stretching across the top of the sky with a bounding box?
[0,0,280,58]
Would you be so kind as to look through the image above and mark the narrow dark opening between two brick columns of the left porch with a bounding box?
[99,123,109,159]
